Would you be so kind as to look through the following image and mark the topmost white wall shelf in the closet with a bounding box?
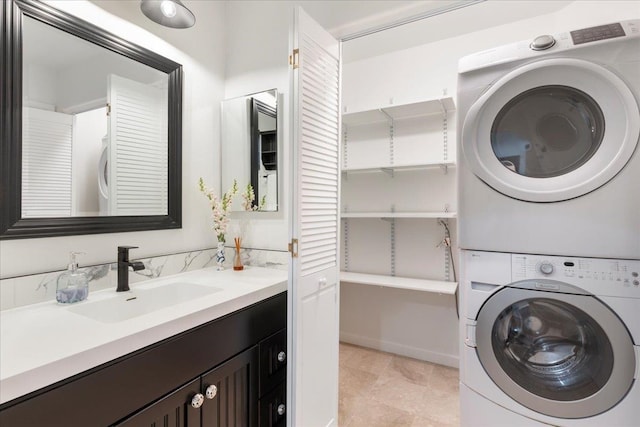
[342,97,455,126]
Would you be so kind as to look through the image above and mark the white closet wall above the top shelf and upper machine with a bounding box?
[342,0,640,111]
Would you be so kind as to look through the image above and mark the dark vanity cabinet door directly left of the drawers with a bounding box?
[201,345,259,427]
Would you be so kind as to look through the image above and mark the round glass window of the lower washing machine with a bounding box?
[491,298,613,401]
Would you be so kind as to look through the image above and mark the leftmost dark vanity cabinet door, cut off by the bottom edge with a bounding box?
[115,378,201,427]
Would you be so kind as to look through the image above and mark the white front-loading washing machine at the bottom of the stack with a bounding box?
[460,251,640,427]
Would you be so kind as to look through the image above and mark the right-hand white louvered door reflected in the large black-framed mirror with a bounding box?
[108,74,169,215]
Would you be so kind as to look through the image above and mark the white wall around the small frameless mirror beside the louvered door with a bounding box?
[225,1,295,251]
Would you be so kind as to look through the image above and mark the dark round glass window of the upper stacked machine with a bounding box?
[491,86,605,178]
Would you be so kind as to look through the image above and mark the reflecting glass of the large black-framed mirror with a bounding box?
[22,16,169,218]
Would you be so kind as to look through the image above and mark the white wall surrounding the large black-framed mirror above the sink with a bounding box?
[0,0,226,278]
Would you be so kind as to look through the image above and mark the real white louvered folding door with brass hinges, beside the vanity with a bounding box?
[288,8,340,427]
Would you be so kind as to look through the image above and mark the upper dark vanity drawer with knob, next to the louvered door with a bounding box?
[260,329,287,396]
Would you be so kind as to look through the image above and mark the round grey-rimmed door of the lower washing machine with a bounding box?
[476,281,635,418]
